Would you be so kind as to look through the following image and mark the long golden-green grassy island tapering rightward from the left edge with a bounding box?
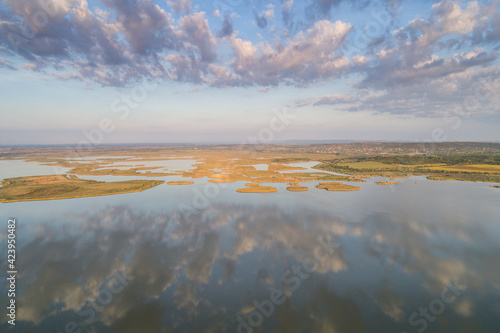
[0,175,164,202]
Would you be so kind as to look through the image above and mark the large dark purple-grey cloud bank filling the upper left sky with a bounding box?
[0,0,222,86]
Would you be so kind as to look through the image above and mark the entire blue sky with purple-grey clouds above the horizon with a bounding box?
[0,0,500,146]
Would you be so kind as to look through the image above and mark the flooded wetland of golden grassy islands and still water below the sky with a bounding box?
[0,144,500,333]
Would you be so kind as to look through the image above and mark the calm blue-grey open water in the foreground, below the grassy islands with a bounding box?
[0,160,500,333]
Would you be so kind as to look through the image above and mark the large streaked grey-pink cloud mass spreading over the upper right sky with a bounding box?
[296,0,500,116]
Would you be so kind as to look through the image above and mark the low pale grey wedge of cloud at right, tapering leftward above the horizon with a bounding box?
[295,60,500,118]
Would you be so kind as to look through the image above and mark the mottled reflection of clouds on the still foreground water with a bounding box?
[0,201,500,332]
